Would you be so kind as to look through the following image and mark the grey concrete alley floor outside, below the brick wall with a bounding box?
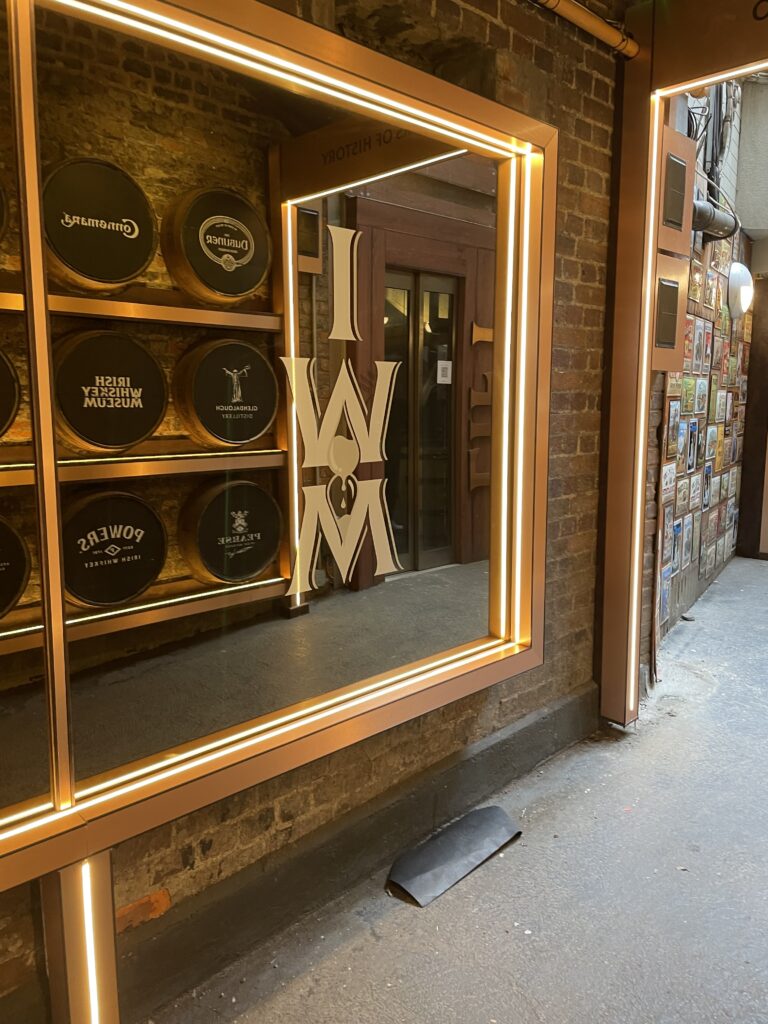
[144,559,768,1024]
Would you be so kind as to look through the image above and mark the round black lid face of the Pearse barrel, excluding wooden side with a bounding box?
[197,480,282,583]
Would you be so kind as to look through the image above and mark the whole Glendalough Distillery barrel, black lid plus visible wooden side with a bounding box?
[173,338,278,446]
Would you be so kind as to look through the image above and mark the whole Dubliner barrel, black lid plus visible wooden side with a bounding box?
[161,188,272,306]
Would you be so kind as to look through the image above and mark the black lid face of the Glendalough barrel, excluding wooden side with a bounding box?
[193,341,278,444]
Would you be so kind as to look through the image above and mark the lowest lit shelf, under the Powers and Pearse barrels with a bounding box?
[0,579,288,654]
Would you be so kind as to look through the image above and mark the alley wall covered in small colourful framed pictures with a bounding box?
[649,216,752,645]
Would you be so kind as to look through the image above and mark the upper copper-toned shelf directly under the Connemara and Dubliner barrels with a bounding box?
[0,288,283,334]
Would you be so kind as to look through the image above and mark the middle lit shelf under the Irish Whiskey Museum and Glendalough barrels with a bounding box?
[0,441,287,487]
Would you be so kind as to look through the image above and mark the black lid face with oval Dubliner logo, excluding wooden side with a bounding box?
[179,188,271,298]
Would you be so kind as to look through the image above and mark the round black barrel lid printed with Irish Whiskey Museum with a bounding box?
[56,331,167,449]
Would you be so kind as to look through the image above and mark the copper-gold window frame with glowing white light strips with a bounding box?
[0,0,557,889]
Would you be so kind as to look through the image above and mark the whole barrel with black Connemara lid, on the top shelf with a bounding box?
[43,158,157,292]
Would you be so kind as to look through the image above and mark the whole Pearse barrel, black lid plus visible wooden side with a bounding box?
[178,480,283,584]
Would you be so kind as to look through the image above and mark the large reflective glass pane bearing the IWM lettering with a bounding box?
[28,11,496,793]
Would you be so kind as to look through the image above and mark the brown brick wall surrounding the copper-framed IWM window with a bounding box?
[0,0,626,1007]
